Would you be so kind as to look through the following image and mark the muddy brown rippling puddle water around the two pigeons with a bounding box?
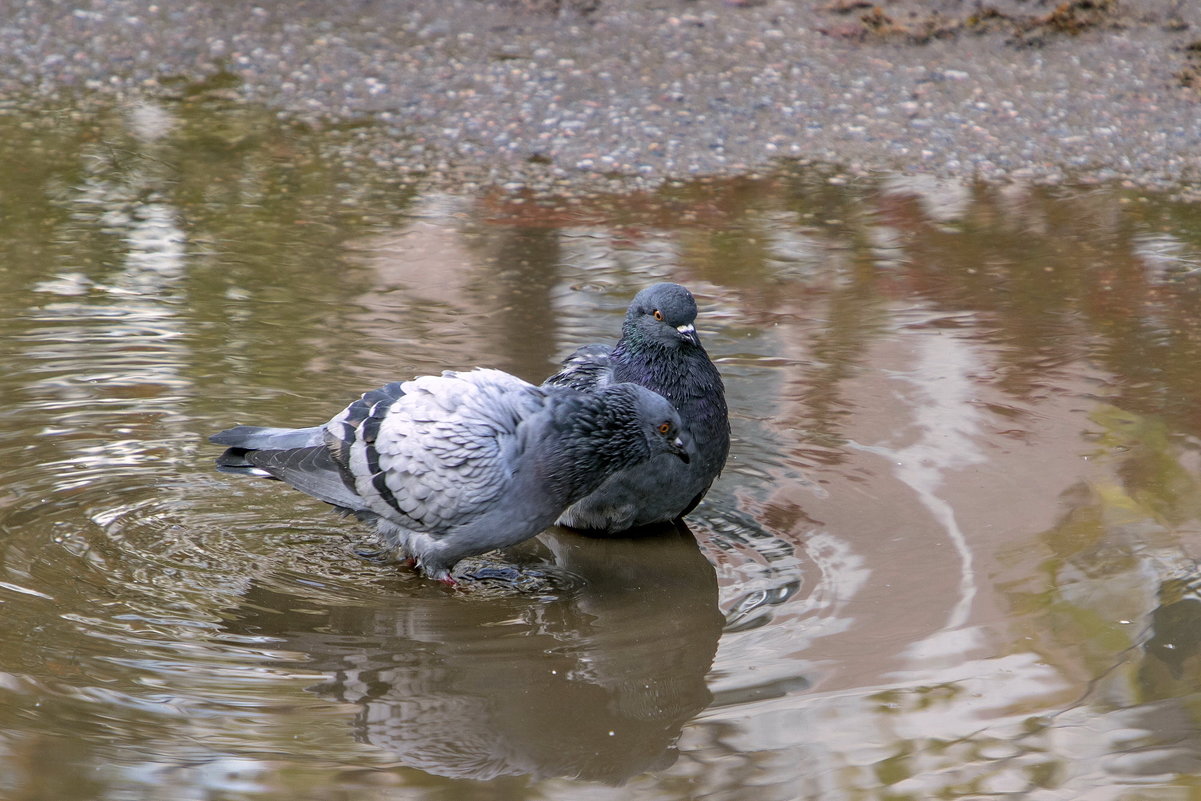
[0,91,1201,801]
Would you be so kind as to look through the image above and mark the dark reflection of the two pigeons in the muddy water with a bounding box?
[220,525,723,784]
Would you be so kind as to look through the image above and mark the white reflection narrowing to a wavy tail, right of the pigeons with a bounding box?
[864,335,985,656]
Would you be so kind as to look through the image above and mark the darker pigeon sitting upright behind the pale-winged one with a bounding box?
[543,283,730,533]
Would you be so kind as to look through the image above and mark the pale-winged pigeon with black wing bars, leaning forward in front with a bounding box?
[210,370,688,584]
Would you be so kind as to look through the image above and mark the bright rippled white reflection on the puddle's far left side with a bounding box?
[20,98,187,490]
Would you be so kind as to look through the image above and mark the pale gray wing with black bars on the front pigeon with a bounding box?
[325,370,546,536]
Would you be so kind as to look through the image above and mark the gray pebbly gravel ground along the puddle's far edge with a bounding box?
[0,0,1201,187]
